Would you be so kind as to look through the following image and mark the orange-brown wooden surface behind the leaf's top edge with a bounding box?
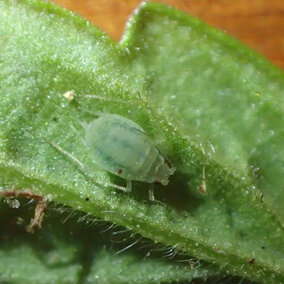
[47,0,284,69]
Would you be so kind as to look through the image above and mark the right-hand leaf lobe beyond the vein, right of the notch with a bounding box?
[123,3,284,224]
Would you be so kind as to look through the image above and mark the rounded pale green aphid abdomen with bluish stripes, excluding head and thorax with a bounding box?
[86,115,153,180]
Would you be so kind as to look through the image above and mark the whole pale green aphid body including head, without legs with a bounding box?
[84,114,175,185]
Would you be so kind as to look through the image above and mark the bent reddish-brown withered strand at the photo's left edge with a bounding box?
[0,188,47,233]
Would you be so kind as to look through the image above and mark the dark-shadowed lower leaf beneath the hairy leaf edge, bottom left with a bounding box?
[0,200,217,284]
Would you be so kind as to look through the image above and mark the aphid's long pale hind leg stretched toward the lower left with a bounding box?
[47,141,131,192]
